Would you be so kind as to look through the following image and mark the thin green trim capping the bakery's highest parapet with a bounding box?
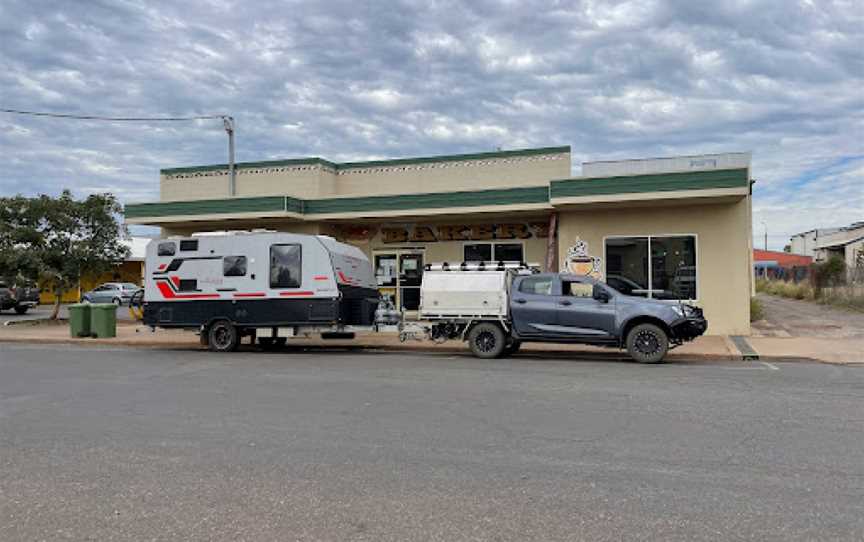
[159,145,570,175]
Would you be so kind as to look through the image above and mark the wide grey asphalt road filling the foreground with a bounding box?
[0,345,864,541]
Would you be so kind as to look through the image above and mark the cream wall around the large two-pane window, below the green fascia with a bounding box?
[558,198,751,335]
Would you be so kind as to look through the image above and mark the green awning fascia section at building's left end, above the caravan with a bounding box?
[124,196,286,218]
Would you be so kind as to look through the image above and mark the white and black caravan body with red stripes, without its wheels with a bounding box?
[144,232,379,336]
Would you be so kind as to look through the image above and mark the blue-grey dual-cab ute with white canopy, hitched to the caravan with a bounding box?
[419,262,708,363]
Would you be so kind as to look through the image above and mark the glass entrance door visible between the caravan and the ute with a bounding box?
[374,249,423,311]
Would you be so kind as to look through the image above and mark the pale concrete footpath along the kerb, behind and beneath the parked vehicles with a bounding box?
[0,321,741,360]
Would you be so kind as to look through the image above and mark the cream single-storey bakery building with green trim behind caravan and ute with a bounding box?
[125,147,752,334]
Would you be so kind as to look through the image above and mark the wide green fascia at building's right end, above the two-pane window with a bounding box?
[549,169,749,200]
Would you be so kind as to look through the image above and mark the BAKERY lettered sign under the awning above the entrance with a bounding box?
[381,222,549,244]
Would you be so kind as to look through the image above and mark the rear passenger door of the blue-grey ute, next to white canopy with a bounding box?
[510,274,557,336]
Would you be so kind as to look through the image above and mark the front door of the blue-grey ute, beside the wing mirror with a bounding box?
[557,277,615,339]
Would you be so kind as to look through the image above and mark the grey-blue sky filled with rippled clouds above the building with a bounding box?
[0,0,864,248]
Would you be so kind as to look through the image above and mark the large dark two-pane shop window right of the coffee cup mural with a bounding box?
[606,235,697,299]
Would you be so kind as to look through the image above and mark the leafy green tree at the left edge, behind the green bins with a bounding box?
[0,190,129,319]
